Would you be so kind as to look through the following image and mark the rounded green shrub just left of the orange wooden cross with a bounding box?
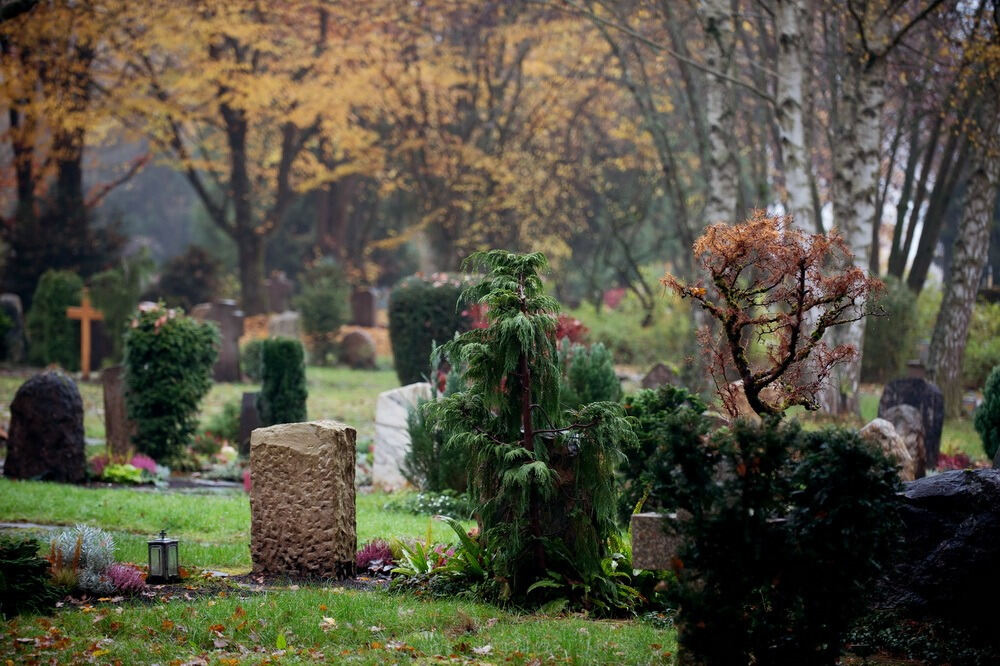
[25,270,83,371]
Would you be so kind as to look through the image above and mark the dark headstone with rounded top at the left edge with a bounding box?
[3,372,87,483]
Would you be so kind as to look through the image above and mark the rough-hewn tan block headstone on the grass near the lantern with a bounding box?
[250,421,357,578]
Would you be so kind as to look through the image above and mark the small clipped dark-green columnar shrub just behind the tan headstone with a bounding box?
[257,338,309,426]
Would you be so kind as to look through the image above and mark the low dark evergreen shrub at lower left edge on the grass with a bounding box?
[0,535,56,618]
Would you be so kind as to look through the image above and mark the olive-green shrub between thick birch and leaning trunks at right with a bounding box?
[861,275,917,384]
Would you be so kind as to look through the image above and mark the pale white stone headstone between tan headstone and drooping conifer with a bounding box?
[372,382,431,490]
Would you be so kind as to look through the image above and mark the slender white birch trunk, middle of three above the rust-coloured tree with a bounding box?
[775,0,816,233]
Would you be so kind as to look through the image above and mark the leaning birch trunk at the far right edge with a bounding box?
[928,128,1000,417]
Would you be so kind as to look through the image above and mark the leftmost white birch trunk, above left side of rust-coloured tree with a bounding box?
[699,0,739,224]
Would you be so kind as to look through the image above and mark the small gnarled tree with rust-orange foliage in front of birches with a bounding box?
[662,210,882,416]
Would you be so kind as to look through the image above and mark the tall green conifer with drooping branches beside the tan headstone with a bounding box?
[430,250,635,607]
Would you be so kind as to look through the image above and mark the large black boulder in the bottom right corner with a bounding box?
[880,469,1000,632]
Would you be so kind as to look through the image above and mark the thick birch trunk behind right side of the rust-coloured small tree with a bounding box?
[820,17,888,414]
